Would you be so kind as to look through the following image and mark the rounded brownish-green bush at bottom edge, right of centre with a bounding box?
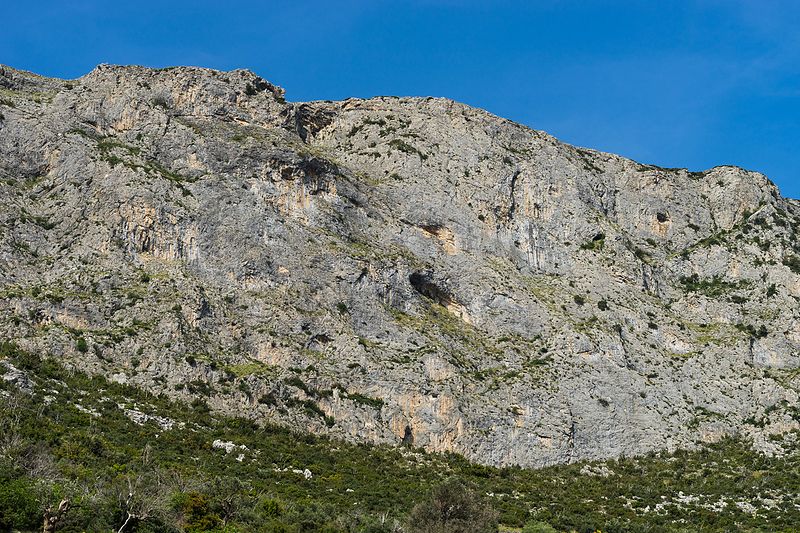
[408,479,498,533]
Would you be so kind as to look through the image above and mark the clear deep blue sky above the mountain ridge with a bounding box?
[0,0,800,198]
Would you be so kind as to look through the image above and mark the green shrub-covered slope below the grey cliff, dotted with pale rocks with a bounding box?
[0,342,800,532]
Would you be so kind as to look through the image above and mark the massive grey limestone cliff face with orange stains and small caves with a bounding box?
[0,65,800,466]
